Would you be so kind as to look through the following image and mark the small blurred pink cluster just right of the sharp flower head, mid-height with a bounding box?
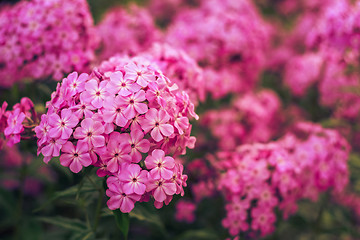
[201,90,282,150]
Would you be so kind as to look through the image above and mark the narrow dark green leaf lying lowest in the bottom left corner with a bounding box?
[37,216,88,232]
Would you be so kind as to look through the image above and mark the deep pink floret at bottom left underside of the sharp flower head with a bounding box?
[60,142,92,173]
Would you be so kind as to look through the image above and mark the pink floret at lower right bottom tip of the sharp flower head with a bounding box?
[146,177,176,203]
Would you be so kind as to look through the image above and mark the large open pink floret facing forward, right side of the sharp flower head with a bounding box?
[140,108,174,142]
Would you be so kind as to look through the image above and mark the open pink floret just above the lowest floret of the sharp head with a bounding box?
[119,164,148,195]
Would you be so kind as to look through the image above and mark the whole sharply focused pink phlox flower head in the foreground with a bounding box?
[35,57,197,212]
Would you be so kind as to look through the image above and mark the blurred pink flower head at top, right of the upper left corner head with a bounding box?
[96,4,161,59]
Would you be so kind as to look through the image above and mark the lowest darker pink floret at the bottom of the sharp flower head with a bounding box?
[106,182,141,213]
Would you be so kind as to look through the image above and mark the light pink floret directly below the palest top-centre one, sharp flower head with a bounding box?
[103,95,128,127]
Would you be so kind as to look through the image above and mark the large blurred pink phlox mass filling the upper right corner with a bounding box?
[270,0,360,122]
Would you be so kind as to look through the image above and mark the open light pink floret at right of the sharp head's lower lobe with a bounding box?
[145,149,175,180]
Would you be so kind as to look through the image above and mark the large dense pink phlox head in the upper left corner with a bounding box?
[0,0,97,87]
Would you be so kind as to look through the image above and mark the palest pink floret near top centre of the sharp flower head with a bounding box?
[106,71,141,96]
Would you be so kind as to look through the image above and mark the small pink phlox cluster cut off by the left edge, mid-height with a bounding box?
[0,97,37,149]
